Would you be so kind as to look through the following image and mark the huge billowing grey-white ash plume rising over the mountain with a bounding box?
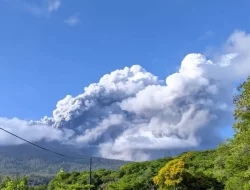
[0,32,250,160]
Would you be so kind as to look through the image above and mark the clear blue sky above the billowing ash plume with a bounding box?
[0,0,250,159]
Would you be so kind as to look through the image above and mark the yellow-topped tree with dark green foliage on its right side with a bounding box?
[154,151,223,190]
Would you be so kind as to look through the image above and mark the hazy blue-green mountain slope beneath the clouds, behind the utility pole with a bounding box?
[0,143,128,176]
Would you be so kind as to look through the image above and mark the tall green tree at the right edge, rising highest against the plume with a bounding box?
[215,77,250,190]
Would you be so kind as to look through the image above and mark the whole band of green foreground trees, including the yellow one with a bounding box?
[0,78,250,190]
